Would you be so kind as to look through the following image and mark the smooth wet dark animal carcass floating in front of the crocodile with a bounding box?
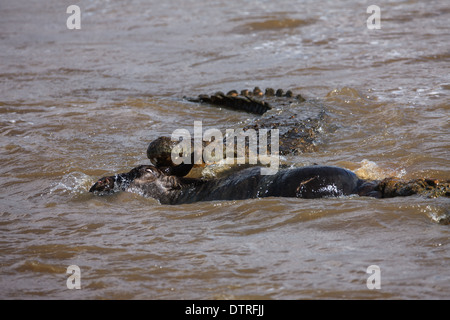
[89,165,363,204]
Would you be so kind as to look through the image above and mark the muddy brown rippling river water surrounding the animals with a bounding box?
[0,0,450,299]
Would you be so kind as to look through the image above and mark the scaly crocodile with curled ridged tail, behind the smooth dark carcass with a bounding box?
[147,87,327,176]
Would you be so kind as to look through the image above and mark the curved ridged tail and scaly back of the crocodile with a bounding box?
[185,87,326,155]
